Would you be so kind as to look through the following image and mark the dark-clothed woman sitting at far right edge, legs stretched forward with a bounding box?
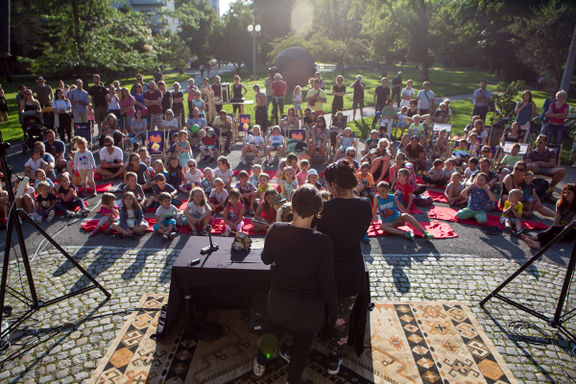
[522,184,576,249]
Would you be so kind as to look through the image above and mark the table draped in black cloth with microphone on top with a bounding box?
[159,236,272,335]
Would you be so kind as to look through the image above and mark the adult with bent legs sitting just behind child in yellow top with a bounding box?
[501,161,554,218]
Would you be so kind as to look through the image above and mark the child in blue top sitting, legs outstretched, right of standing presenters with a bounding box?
[372,181,434,240]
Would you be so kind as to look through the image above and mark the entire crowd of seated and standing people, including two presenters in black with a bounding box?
[0,68,576,383]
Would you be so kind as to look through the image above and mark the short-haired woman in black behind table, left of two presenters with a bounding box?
[253,185,337,384]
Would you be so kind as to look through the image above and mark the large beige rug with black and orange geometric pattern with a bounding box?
[90,294,517,384]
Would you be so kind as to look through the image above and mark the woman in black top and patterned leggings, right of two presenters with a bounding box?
[315,161,372,375]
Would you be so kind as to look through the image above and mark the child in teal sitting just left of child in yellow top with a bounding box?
[456,172,496,224]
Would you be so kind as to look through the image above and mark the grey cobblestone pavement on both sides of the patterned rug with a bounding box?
[0,244,576,383]
